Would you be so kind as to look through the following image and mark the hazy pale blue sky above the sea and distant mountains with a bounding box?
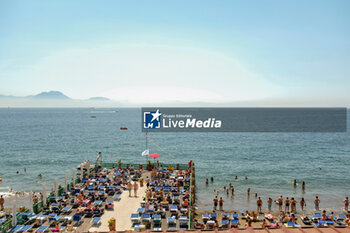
[0,0,350,106]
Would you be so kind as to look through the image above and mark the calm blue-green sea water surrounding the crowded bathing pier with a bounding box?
[0,108,350,212]
